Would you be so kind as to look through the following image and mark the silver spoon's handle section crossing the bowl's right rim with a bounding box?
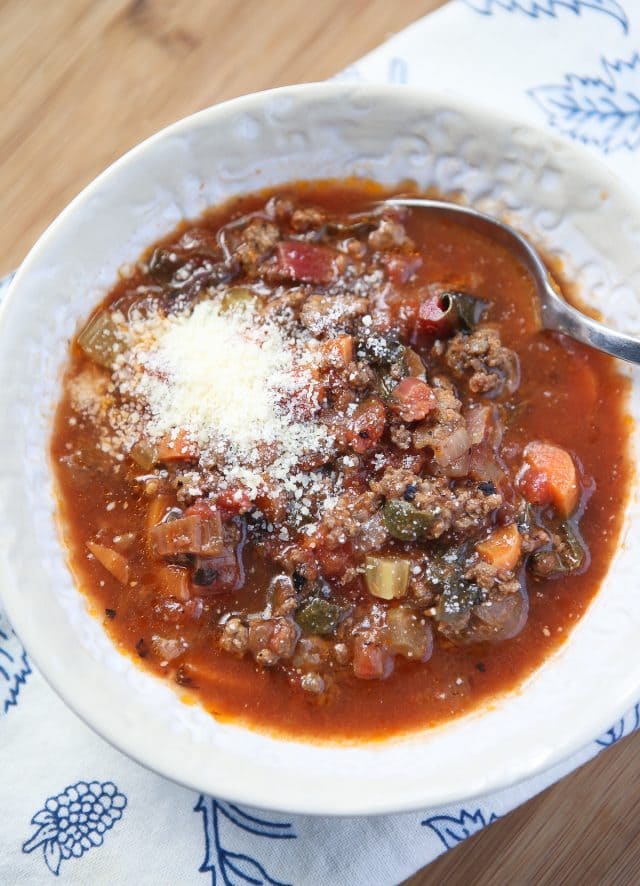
[540,284,640,363]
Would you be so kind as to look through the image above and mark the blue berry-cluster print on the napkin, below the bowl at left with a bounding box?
[22,781,127,877]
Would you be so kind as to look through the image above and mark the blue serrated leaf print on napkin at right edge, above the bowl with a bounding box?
[529,52,640,154]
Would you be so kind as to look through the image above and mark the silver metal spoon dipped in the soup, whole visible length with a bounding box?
[381,197,640,363]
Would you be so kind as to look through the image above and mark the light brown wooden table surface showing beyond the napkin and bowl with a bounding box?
[0,0,640,886]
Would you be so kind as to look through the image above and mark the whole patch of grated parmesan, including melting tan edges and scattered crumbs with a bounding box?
[73,298,333,510]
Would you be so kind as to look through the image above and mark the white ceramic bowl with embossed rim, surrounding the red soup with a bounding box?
[0,84,640,814]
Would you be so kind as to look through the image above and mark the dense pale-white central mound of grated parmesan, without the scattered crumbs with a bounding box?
[127,301,312,454]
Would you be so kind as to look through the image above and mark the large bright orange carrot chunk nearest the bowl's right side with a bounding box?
[519,440,580,517]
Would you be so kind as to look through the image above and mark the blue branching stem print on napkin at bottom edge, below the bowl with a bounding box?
[194,794,296,886]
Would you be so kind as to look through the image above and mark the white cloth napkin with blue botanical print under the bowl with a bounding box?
[0,0,640,886]
